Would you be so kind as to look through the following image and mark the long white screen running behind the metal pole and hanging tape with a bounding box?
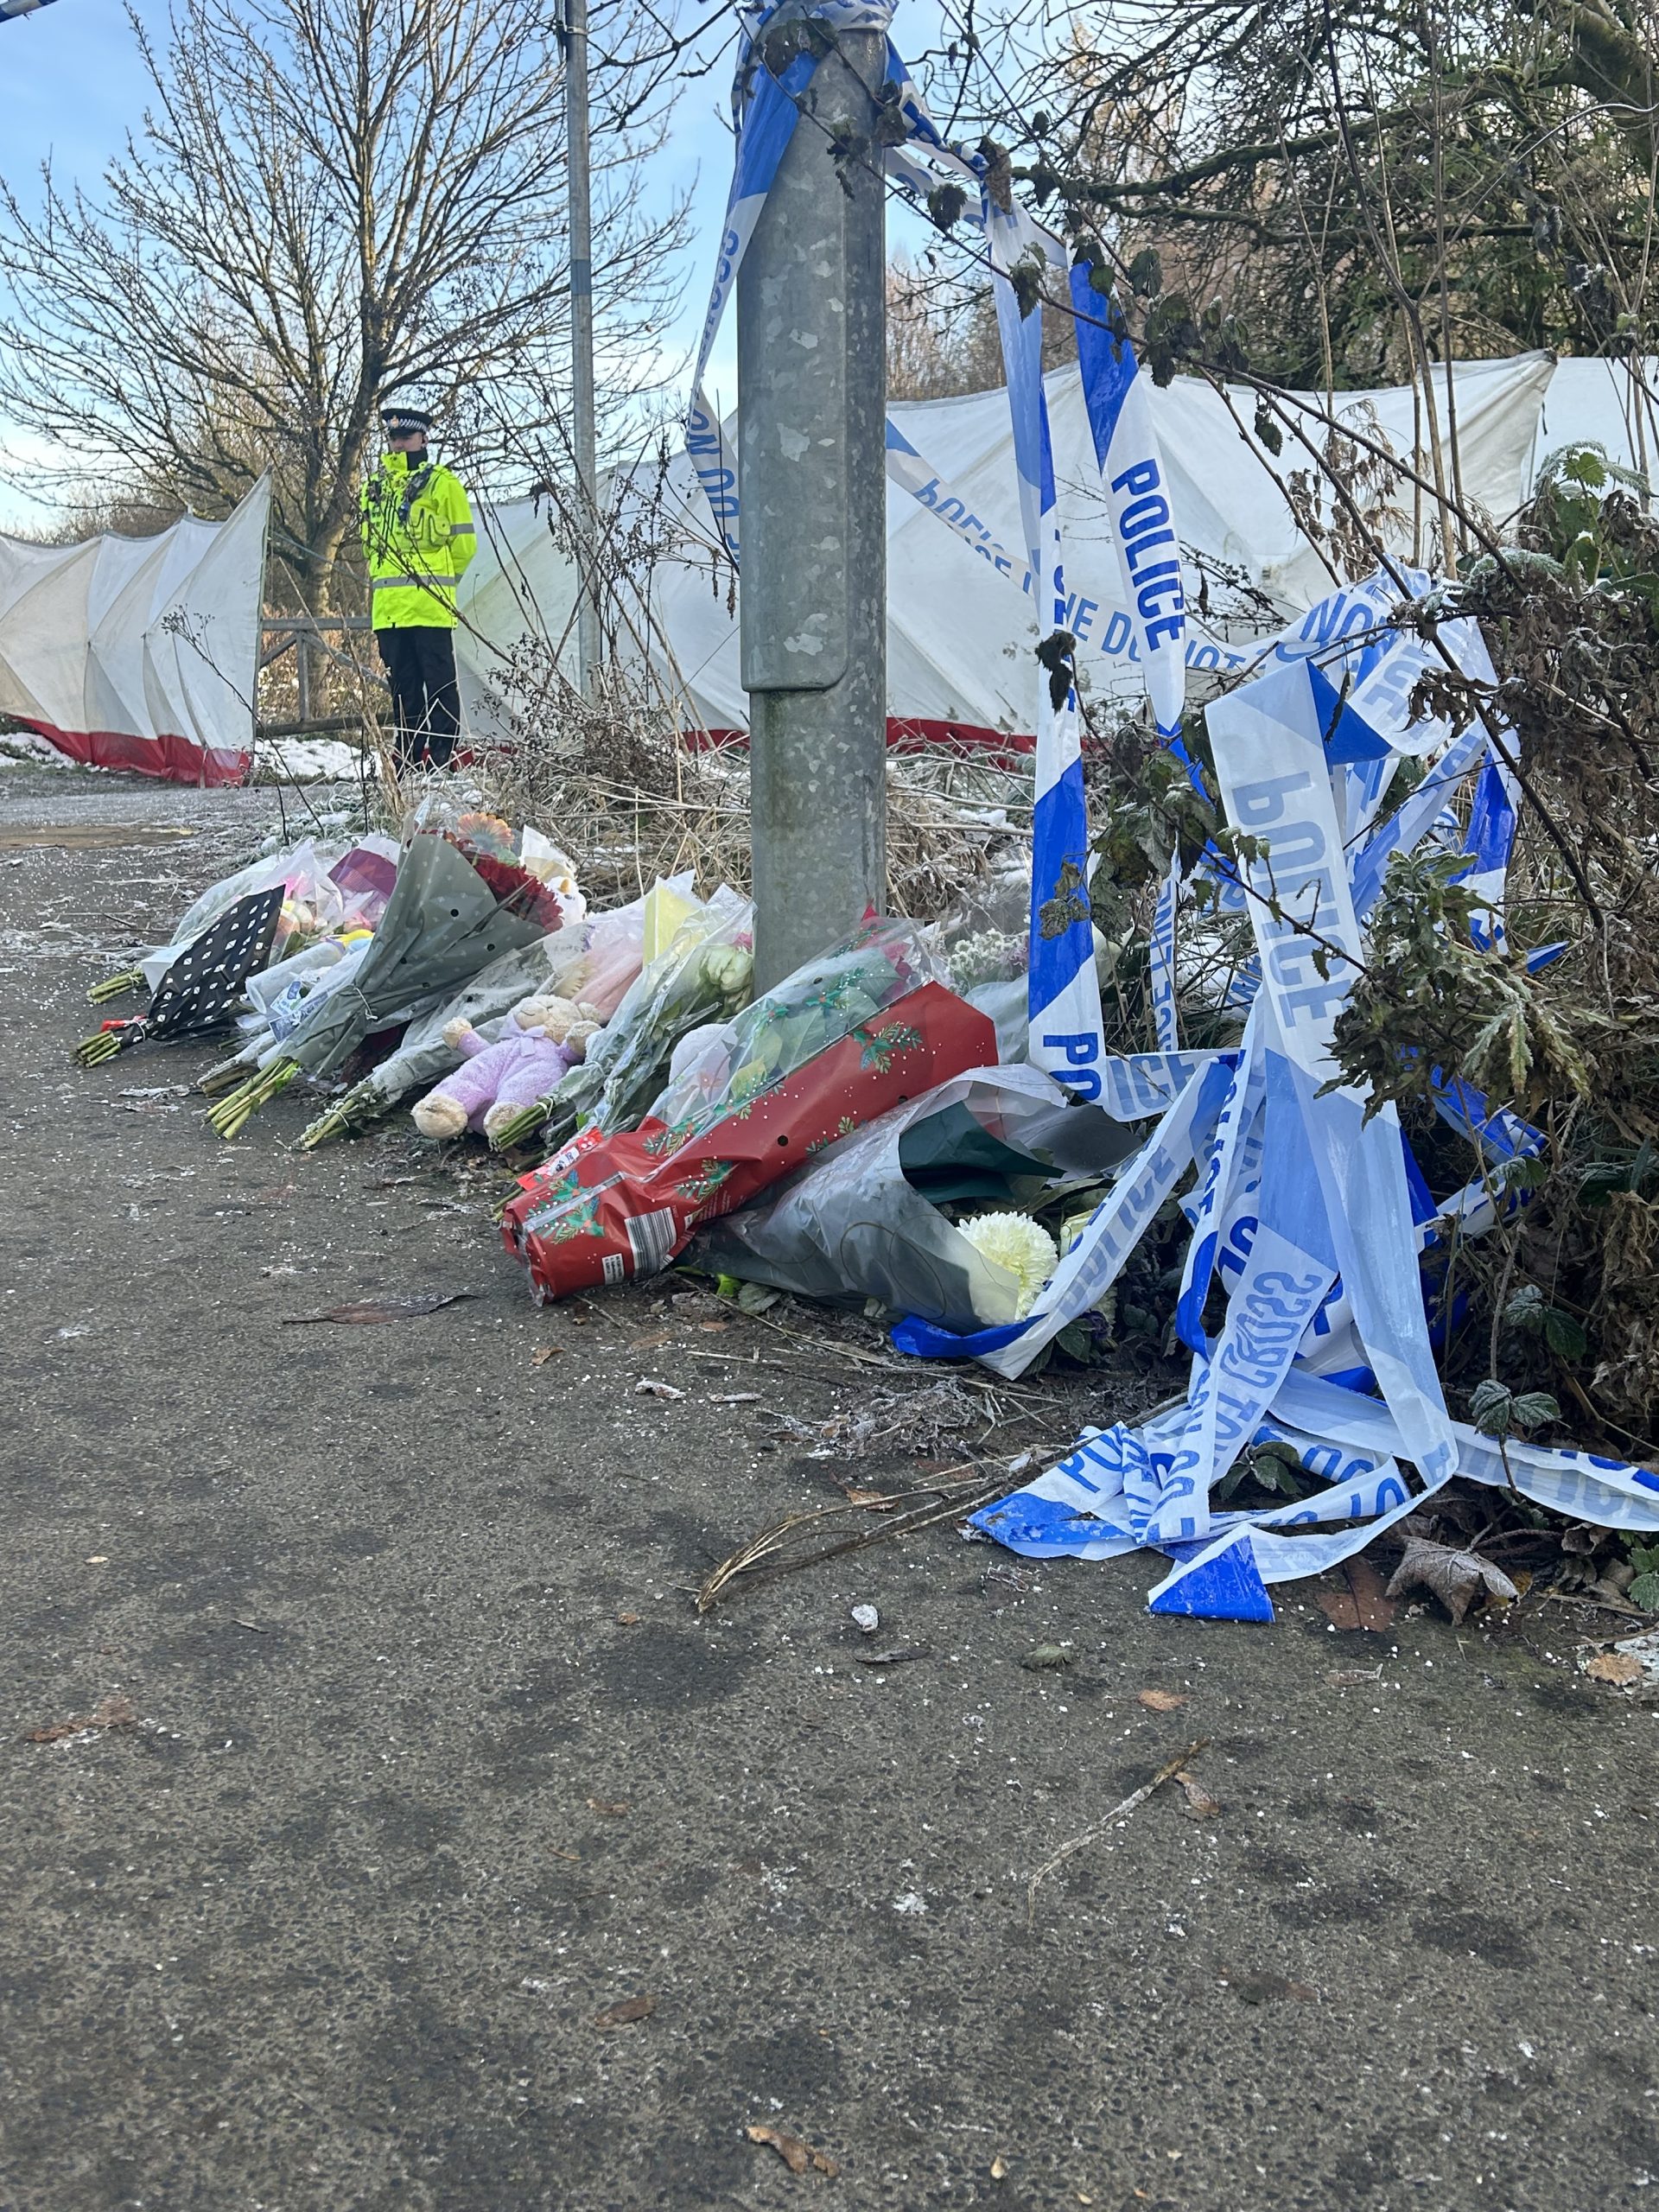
[460,354,1566,741]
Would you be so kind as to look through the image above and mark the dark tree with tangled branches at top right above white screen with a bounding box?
[929,0,1659,390]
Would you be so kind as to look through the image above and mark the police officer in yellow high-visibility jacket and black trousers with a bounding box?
[360,404,475,770]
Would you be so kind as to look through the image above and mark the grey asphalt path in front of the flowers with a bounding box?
[0,770,1659,2212]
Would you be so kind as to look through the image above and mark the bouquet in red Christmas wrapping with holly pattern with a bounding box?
[502,923,995,1299]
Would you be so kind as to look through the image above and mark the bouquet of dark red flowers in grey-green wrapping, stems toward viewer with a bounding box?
[208,817,562,1137]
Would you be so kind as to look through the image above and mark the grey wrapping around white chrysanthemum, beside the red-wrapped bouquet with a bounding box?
[696,1066,1133,1332]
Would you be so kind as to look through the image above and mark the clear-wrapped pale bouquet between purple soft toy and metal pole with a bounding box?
[491,887,754,1153]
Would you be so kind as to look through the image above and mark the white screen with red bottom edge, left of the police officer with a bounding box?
[0,478,270,783]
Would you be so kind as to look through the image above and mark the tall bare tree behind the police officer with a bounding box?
[0,0,683,608]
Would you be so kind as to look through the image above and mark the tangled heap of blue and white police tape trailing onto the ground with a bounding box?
[911,648,1659,1619]
